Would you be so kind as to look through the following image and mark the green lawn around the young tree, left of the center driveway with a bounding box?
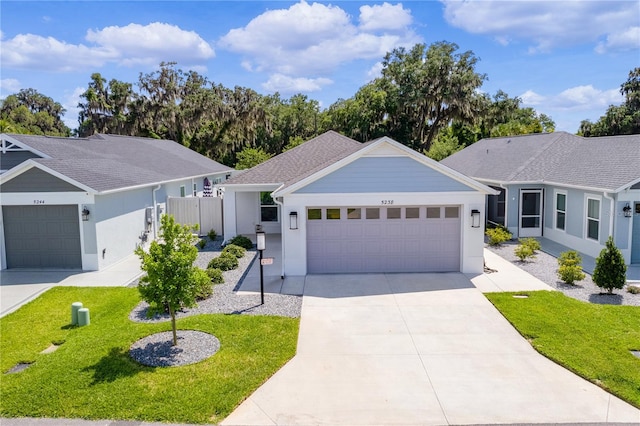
[0,287,299,423]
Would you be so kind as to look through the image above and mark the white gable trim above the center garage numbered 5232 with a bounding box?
[273,136,499,197]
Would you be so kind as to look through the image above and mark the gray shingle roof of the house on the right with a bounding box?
[442,132,640,191]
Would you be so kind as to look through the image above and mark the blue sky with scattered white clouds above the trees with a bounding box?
[0,0,640,133]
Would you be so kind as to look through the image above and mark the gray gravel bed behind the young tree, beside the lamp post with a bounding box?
[129,239,302,322]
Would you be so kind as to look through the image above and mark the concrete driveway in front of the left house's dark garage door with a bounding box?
[0,254,142,317]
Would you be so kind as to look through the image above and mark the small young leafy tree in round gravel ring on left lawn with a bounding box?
[135,215,211,346]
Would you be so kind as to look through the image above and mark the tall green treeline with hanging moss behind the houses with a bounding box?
[0,41,556,167]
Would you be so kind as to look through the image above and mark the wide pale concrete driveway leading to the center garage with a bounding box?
[222,273,640,425]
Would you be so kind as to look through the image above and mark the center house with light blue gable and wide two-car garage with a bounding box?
[221,131,497,276]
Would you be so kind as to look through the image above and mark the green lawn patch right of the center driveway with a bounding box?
[486,291,640,408]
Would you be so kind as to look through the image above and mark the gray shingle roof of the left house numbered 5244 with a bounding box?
[2,135,232,192]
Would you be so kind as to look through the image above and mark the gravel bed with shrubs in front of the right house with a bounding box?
[486,242,640,306]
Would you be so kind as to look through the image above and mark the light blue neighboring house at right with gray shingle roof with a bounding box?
[442,132,640,264]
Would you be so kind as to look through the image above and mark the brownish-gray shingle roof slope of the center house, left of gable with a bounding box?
[225,131,365,188]
